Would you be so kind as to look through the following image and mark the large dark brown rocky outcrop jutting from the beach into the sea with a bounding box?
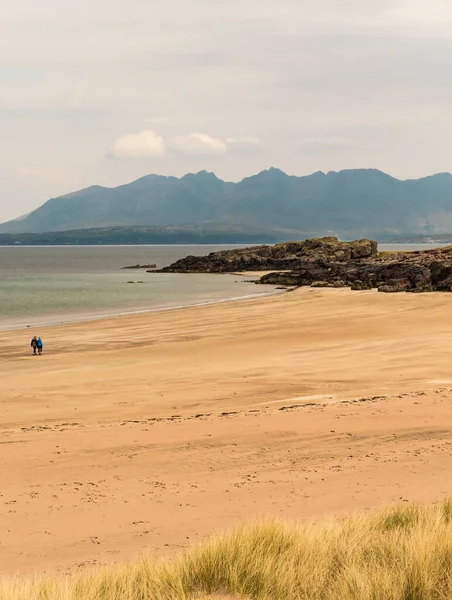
[158,237,452,293]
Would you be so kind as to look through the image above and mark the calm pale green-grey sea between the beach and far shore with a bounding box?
[0,244,446,330]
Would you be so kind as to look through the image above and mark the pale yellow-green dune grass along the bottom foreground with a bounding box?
[0,500,452,600]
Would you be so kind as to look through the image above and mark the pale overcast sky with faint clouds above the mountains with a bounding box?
[0,0,452,221]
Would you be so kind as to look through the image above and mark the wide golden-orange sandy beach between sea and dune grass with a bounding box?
[0,288,452,573]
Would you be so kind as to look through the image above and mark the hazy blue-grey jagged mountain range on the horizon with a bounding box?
[0,168,452,242]
